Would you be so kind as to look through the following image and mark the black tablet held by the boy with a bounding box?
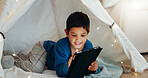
[66,46,102,78]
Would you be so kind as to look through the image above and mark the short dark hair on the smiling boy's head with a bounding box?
[66,12,90,34]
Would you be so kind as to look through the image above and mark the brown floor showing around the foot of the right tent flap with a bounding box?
[121,53,148,78]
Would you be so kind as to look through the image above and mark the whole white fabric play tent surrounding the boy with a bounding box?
[0,0,148,78]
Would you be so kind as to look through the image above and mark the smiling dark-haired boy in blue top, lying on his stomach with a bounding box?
[44,12,99,77]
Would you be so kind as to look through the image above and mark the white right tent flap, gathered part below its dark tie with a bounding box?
[112,24,148,72]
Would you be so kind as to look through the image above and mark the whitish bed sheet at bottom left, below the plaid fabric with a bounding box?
[4,66,59,78]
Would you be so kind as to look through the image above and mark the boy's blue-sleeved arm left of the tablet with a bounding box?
[54,44,70,77]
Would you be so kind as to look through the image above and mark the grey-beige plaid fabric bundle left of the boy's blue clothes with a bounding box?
[15,42,46,73]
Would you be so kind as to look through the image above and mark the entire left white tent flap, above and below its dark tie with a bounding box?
[0,0,34,78]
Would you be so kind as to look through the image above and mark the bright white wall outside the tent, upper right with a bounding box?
[106,0,148,53]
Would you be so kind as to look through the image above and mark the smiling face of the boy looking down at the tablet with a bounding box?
[66,27,88,49]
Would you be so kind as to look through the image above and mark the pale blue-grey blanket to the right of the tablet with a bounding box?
[84,57,123,78]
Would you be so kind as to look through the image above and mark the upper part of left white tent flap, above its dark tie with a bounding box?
[0,0,34,33]
